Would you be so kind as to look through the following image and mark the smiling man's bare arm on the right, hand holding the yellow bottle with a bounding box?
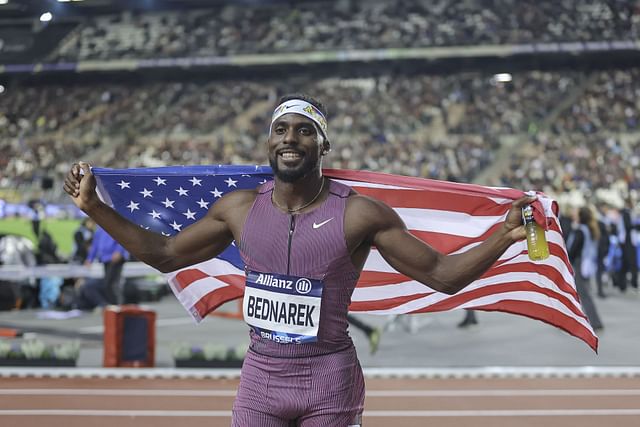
[347,196,535,294]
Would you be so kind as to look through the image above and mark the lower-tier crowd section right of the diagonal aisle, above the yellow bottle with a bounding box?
[498,69,640,200]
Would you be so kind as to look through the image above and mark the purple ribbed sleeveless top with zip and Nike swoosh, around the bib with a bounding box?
[239,181,359,357]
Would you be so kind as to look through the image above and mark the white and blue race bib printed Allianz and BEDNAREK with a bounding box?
[242,271,323,344]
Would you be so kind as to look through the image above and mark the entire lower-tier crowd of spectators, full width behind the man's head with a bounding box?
[0,69,640,203]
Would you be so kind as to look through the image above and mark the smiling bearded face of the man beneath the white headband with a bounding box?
[268,113,328,182]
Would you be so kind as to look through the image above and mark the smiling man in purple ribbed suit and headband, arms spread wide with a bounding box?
[64,95,535,427]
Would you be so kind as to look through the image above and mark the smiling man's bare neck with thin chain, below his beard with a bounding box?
[271,171,326,213]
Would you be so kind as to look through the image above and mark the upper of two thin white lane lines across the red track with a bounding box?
[0,388,640,397]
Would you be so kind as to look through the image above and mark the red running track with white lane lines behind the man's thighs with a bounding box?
[0,377,640,427]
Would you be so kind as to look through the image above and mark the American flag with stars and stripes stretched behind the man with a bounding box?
[93,165,598,350]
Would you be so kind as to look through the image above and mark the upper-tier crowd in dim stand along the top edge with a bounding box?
[50,0,640,61]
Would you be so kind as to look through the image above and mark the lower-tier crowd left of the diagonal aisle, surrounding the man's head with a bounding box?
[0,72,582,191]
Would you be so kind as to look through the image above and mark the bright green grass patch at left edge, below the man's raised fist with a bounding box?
[0,218,80,257]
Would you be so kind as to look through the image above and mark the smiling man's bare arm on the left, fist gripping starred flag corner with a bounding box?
[64,164,251,272]
